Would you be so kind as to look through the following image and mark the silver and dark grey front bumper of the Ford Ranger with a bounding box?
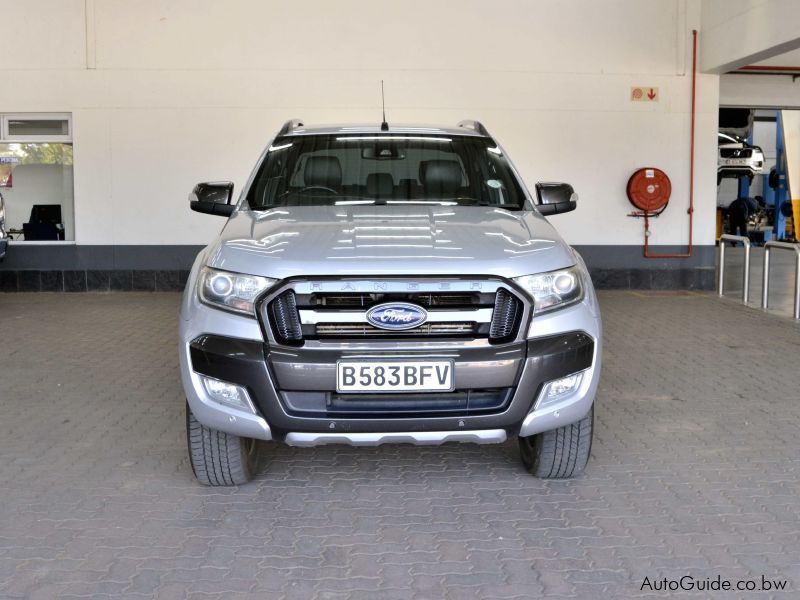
[180,294,601,446]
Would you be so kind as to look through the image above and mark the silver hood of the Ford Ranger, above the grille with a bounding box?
[208,204,575,279]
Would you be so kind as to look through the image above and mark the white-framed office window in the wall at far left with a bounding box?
[0,114,75,242]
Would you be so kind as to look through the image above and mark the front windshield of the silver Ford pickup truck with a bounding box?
[247,133,525,210]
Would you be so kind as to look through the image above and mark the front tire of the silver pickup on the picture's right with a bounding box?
[519,405,594,479]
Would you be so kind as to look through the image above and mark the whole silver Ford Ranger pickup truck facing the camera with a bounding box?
[179,121,602,485]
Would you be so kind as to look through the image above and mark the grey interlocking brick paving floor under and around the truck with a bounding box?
[0,292,800,600]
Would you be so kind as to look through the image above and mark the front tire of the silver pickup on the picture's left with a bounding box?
[186,402,257,486]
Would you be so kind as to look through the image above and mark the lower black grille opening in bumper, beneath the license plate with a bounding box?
[281,388,513,418]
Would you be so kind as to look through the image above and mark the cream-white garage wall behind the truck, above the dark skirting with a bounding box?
[0,0,718,245]
